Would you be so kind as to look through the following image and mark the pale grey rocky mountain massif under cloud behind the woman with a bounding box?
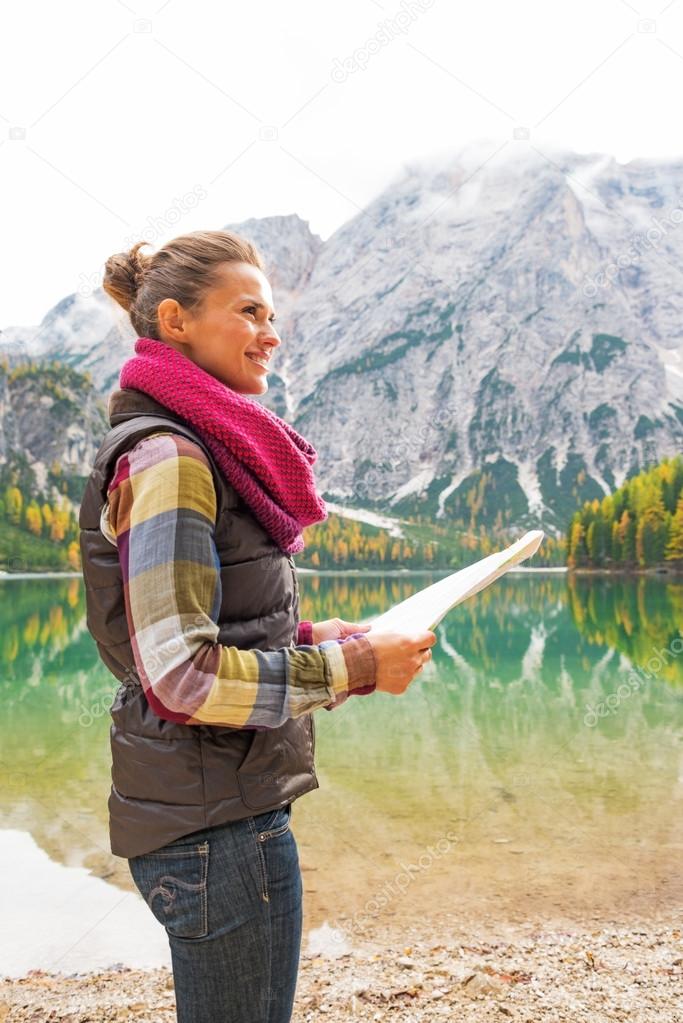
[5,147,683,533]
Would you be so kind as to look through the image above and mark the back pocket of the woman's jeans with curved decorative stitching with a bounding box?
[128,842,209,938]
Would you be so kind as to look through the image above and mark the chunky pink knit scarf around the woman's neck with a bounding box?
[120,338,327,554]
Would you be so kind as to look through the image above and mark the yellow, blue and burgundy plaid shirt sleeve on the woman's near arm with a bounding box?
[100,433,376,729]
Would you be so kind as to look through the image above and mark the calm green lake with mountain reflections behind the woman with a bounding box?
[0,573,683,972]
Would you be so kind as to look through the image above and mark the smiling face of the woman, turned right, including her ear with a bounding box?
[157,263,281,394]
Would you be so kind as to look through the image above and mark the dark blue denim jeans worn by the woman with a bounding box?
[128,803,303,1023]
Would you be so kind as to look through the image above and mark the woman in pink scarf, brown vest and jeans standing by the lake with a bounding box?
[80,231,436,1023]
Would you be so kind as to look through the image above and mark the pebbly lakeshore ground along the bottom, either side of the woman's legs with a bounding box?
[0,925,683,1023]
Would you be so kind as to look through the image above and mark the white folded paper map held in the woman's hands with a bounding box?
[370,529,544,632]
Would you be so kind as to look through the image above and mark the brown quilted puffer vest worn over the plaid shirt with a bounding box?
[79,388,318,857]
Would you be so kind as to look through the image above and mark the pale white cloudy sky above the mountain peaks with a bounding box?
[0,0,683,328]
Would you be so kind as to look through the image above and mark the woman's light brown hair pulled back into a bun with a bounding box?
[102,231,265,341]
